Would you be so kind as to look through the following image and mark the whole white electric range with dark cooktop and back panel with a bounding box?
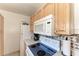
[26,36,61,56]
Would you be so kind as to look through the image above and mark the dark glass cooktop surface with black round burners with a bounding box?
[29,43,57,56]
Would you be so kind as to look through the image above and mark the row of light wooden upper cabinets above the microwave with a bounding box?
[34,3,55,21]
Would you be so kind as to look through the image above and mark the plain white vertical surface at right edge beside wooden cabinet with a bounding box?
[74,3,79,34]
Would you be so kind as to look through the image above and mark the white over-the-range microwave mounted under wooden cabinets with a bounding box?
[34,15,54,36]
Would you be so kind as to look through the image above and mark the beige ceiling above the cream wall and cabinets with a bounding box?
[0,3,43,16]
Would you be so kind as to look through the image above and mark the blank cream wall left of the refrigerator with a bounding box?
[0,10,29,54]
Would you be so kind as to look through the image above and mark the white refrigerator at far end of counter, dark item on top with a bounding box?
[20,23,31,56]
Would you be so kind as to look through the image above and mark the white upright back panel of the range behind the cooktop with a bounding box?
[40,36,60,51]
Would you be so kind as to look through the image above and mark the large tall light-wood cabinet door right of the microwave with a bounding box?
[55,3,71,34]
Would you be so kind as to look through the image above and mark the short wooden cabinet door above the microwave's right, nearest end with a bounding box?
[44,3,54,16]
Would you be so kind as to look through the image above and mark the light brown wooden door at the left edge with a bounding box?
[0,15,4,55]
